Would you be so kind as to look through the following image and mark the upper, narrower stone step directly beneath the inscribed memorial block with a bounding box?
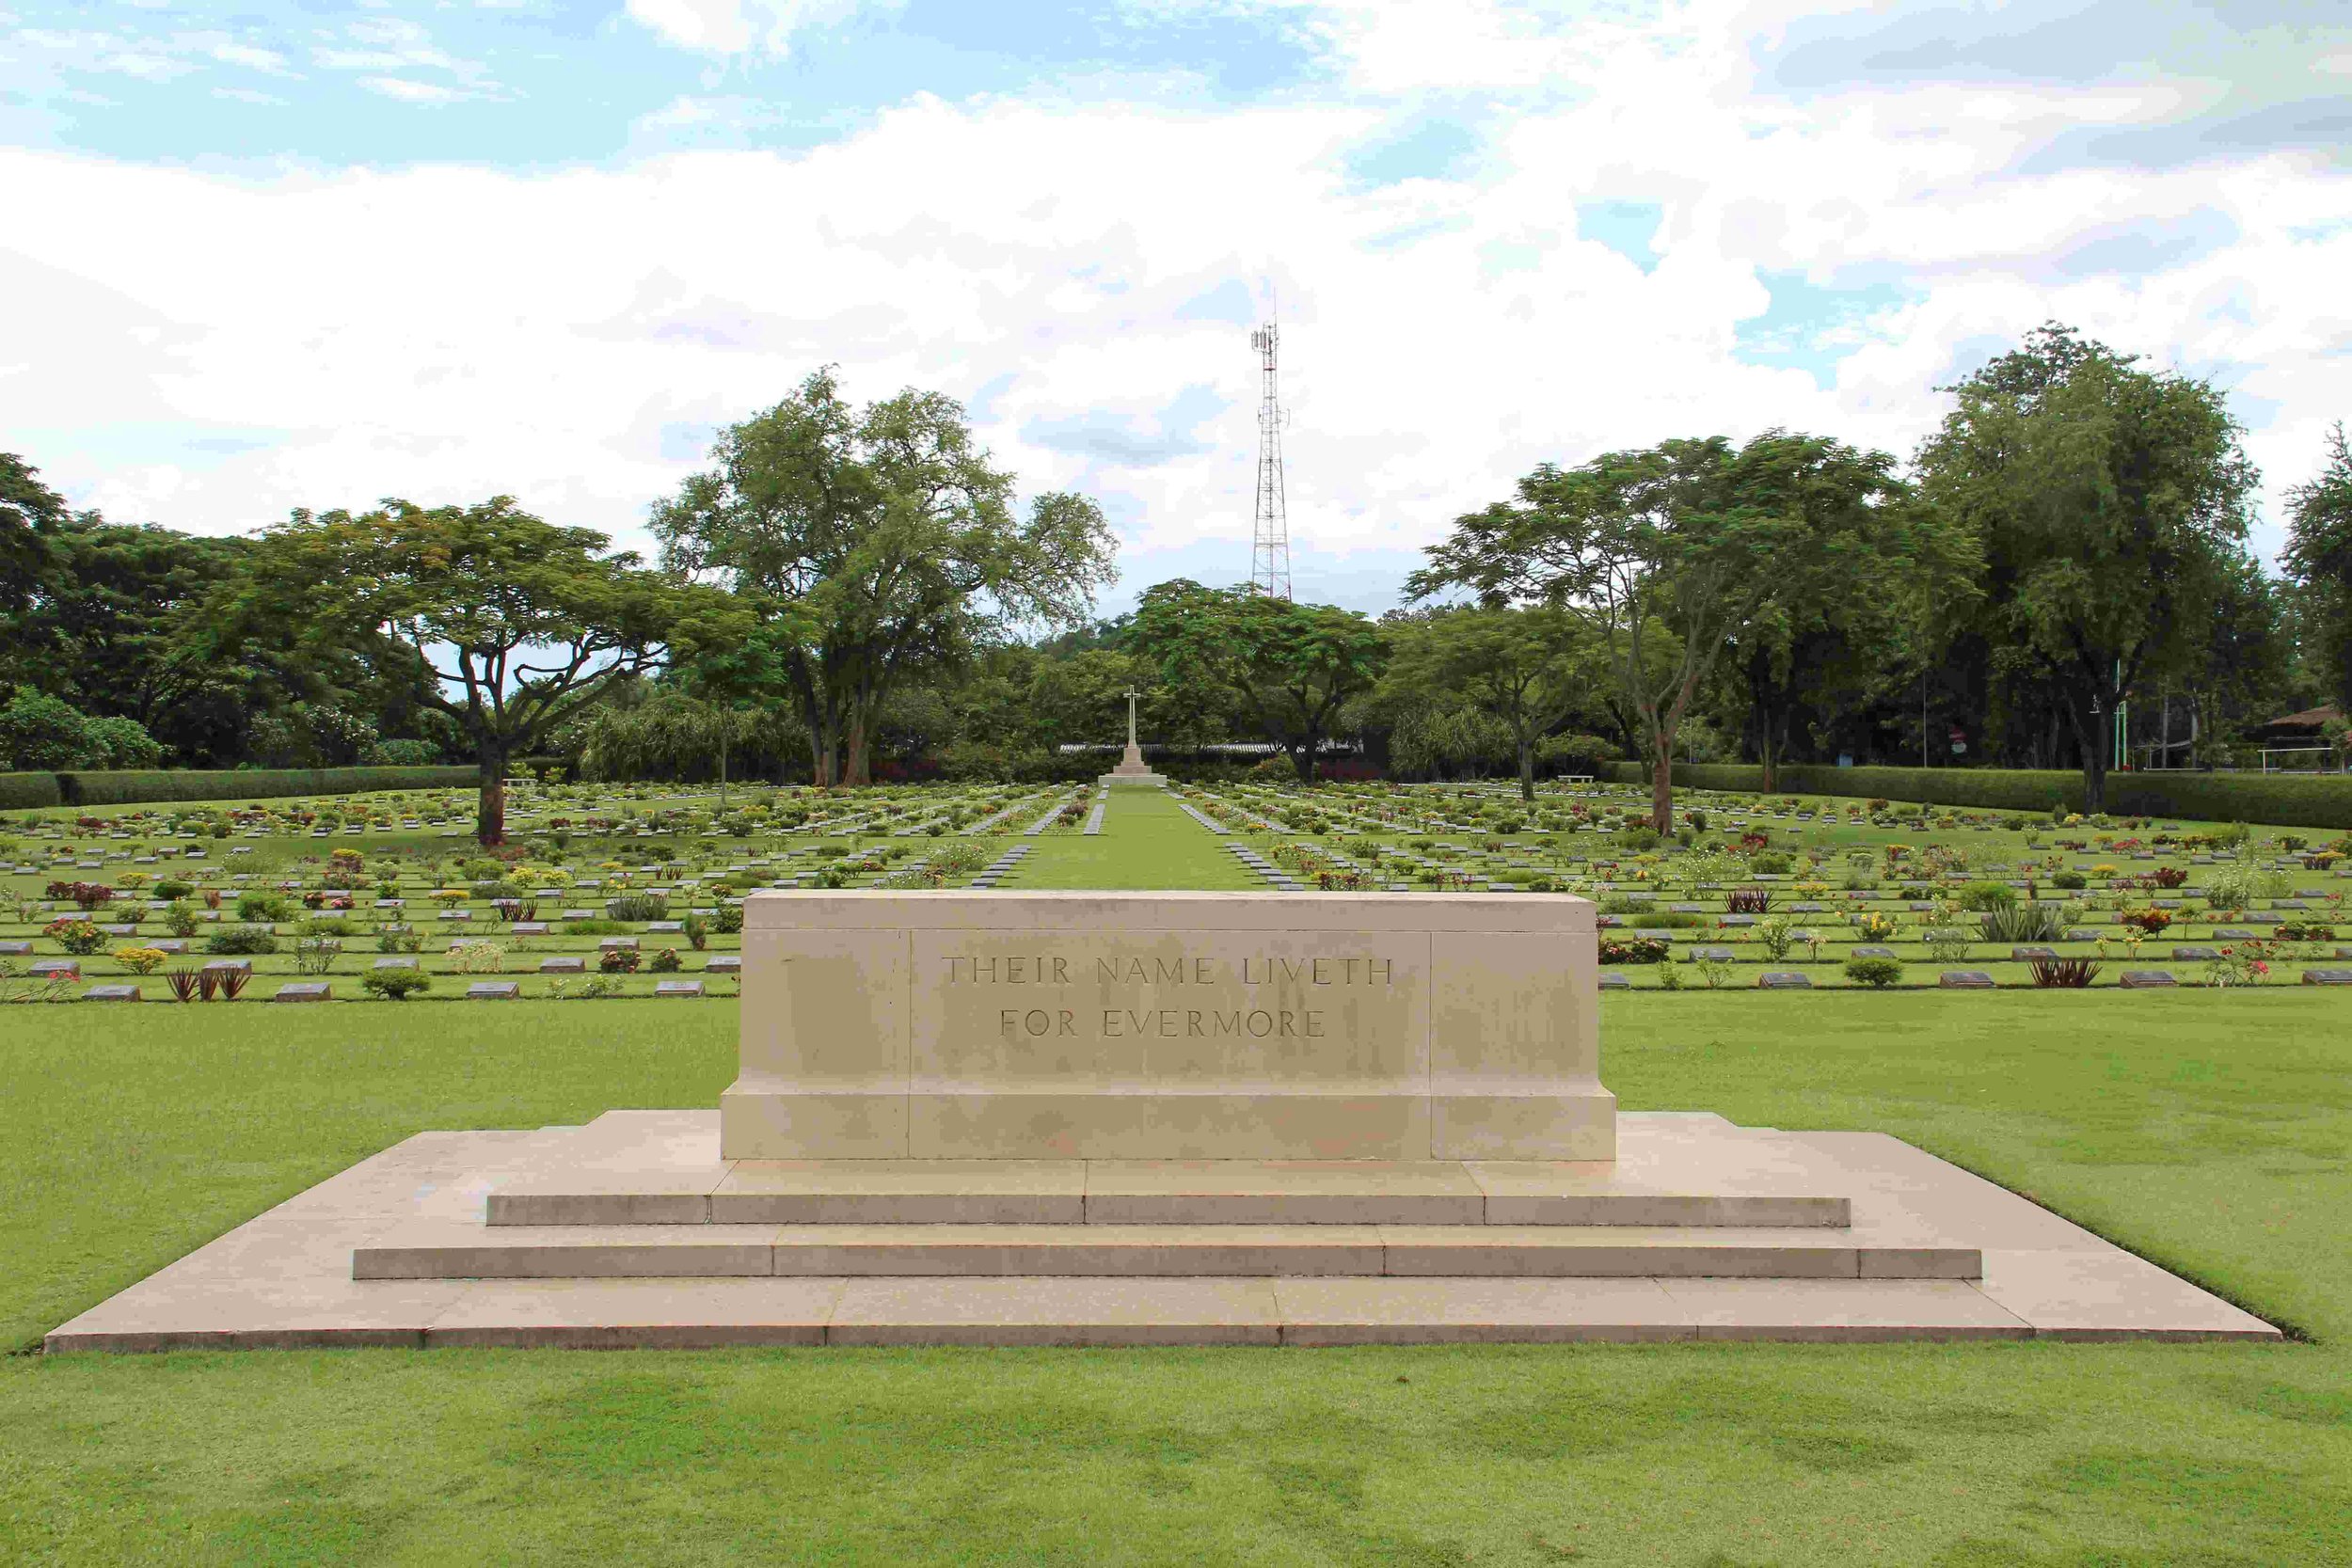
[487,1159,1851,1227]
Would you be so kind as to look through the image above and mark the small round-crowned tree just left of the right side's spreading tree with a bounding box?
[1383,607,1607,800]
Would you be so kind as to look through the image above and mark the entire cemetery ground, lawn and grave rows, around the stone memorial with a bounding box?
[0,783,2352,1566]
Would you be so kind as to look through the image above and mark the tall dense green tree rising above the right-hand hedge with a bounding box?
[1917,322,2256,811]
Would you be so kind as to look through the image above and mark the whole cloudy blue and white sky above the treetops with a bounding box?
[0,0,2352,611]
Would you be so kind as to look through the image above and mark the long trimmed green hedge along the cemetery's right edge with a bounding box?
[1599,762,2352,830]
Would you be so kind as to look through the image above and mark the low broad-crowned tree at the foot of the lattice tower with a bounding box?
[1129,578,1388,783]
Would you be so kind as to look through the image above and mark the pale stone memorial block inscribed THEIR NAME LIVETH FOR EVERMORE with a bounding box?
[723,891,1616,1159]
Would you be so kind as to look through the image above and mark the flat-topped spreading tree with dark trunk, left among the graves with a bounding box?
[216,496,727,847]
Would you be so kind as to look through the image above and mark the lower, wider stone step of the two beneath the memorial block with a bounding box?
[351,1220,1983,1279]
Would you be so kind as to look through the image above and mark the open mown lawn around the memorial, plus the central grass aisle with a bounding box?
[0,795,2352,1568]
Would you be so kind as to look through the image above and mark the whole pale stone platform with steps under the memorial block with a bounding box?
[47,1112,2277,1352]
